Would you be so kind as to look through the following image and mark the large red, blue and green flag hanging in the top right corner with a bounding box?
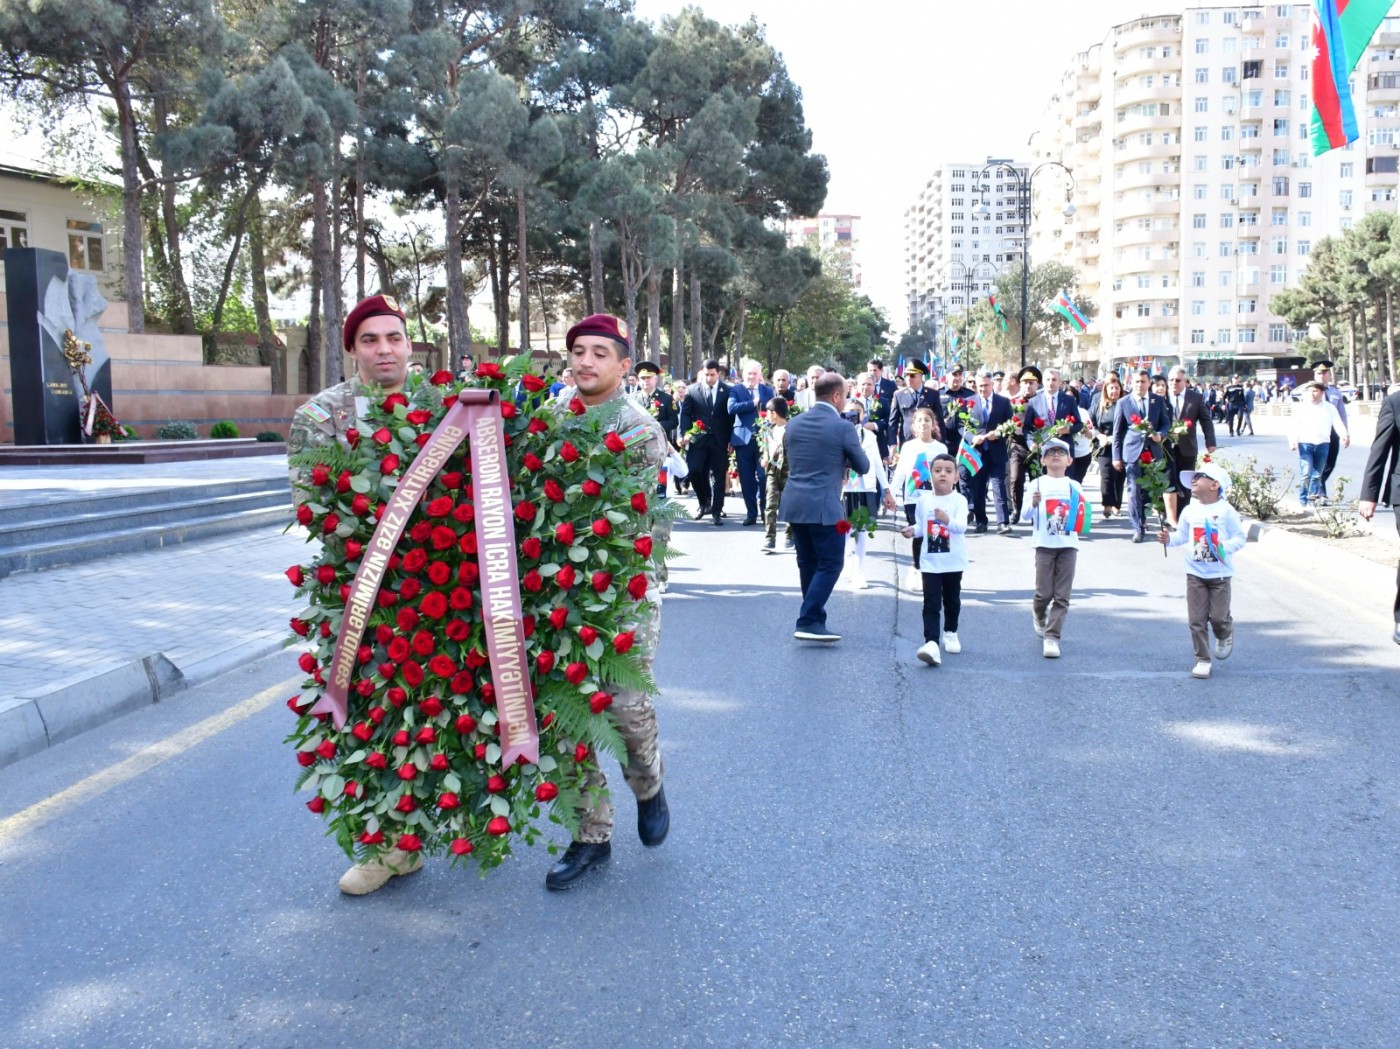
[1312,0,1392,157]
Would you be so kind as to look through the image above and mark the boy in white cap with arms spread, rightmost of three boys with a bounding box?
[1156,462,1249,678]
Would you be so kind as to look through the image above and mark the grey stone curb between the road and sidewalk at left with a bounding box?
[0,636,286,769]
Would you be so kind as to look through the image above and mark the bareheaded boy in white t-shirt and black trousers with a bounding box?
[903,452,967,667]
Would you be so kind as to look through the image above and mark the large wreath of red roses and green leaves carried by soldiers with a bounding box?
[287,360,666,870]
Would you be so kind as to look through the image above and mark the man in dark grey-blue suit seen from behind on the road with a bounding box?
[778,371,873,641]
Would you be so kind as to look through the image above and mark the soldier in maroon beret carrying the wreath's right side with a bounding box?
[545,314,671,891]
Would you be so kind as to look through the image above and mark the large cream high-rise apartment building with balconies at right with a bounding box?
[1030,4,1400,374]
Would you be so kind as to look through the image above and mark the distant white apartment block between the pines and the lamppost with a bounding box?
[904,157,1039,347]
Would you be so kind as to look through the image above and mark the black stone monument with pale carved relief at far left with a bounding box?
[4,248,112,445]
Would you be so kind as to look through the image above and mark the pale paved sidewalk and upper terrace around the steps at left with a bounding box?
[0,457,312,766]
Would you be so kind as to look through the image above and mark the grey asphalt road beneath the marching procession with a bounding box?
[0,501,1400,1049]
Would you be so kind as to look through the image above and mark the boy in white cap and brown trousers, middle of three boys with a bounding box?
[1021,438,1089,660]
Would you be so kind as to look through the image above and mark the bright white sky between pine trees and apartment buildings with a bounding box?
[634,0,1184,332]
